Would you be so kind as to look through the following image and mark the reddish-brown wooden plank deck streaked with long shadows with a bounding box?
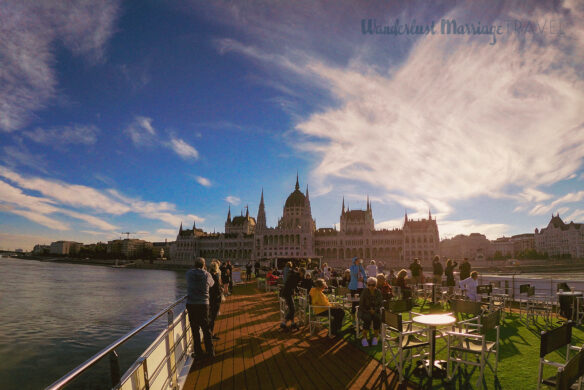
[184,283,411,390]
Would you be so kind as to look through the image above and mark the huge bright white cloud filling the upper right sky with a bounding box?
[208,1,584,229]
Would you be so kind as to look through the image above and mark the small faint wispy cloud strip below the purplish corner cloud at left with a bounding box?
[23,124,99,145]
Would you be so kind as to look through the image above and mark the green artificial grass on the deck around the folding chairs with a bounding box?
[344,307,584,390]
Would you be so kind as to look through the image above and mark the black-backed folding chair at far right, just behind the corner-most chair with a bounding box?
[537,322,581,389]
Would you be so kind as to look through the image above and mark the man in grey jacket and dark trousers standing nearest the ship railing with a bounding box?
[186,257,215,359]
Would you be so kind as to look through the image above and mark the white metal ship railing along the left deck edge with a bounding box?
[46,295,193,390]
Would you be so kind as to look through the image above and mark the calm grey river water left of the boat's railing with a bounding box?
[0,256,186,390]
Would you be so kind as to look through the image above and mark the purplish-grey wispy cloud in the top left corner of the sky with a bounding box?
[0,0,119,131]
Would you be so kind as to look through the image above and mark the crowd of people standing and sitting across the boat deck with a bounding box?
[186,256,478,358]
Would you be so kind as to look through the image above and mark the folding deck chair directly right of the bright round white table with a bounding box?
[446,310,501,388]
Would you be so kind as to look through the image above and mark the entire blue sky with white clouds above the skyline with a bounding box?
[0,0,584,250]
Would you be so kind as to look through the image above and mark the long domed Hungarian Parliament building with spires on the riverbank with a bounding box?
[169,177,440,267]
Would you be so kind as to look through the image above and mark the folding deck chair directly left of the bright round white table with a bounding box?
[381,310,430,383]
